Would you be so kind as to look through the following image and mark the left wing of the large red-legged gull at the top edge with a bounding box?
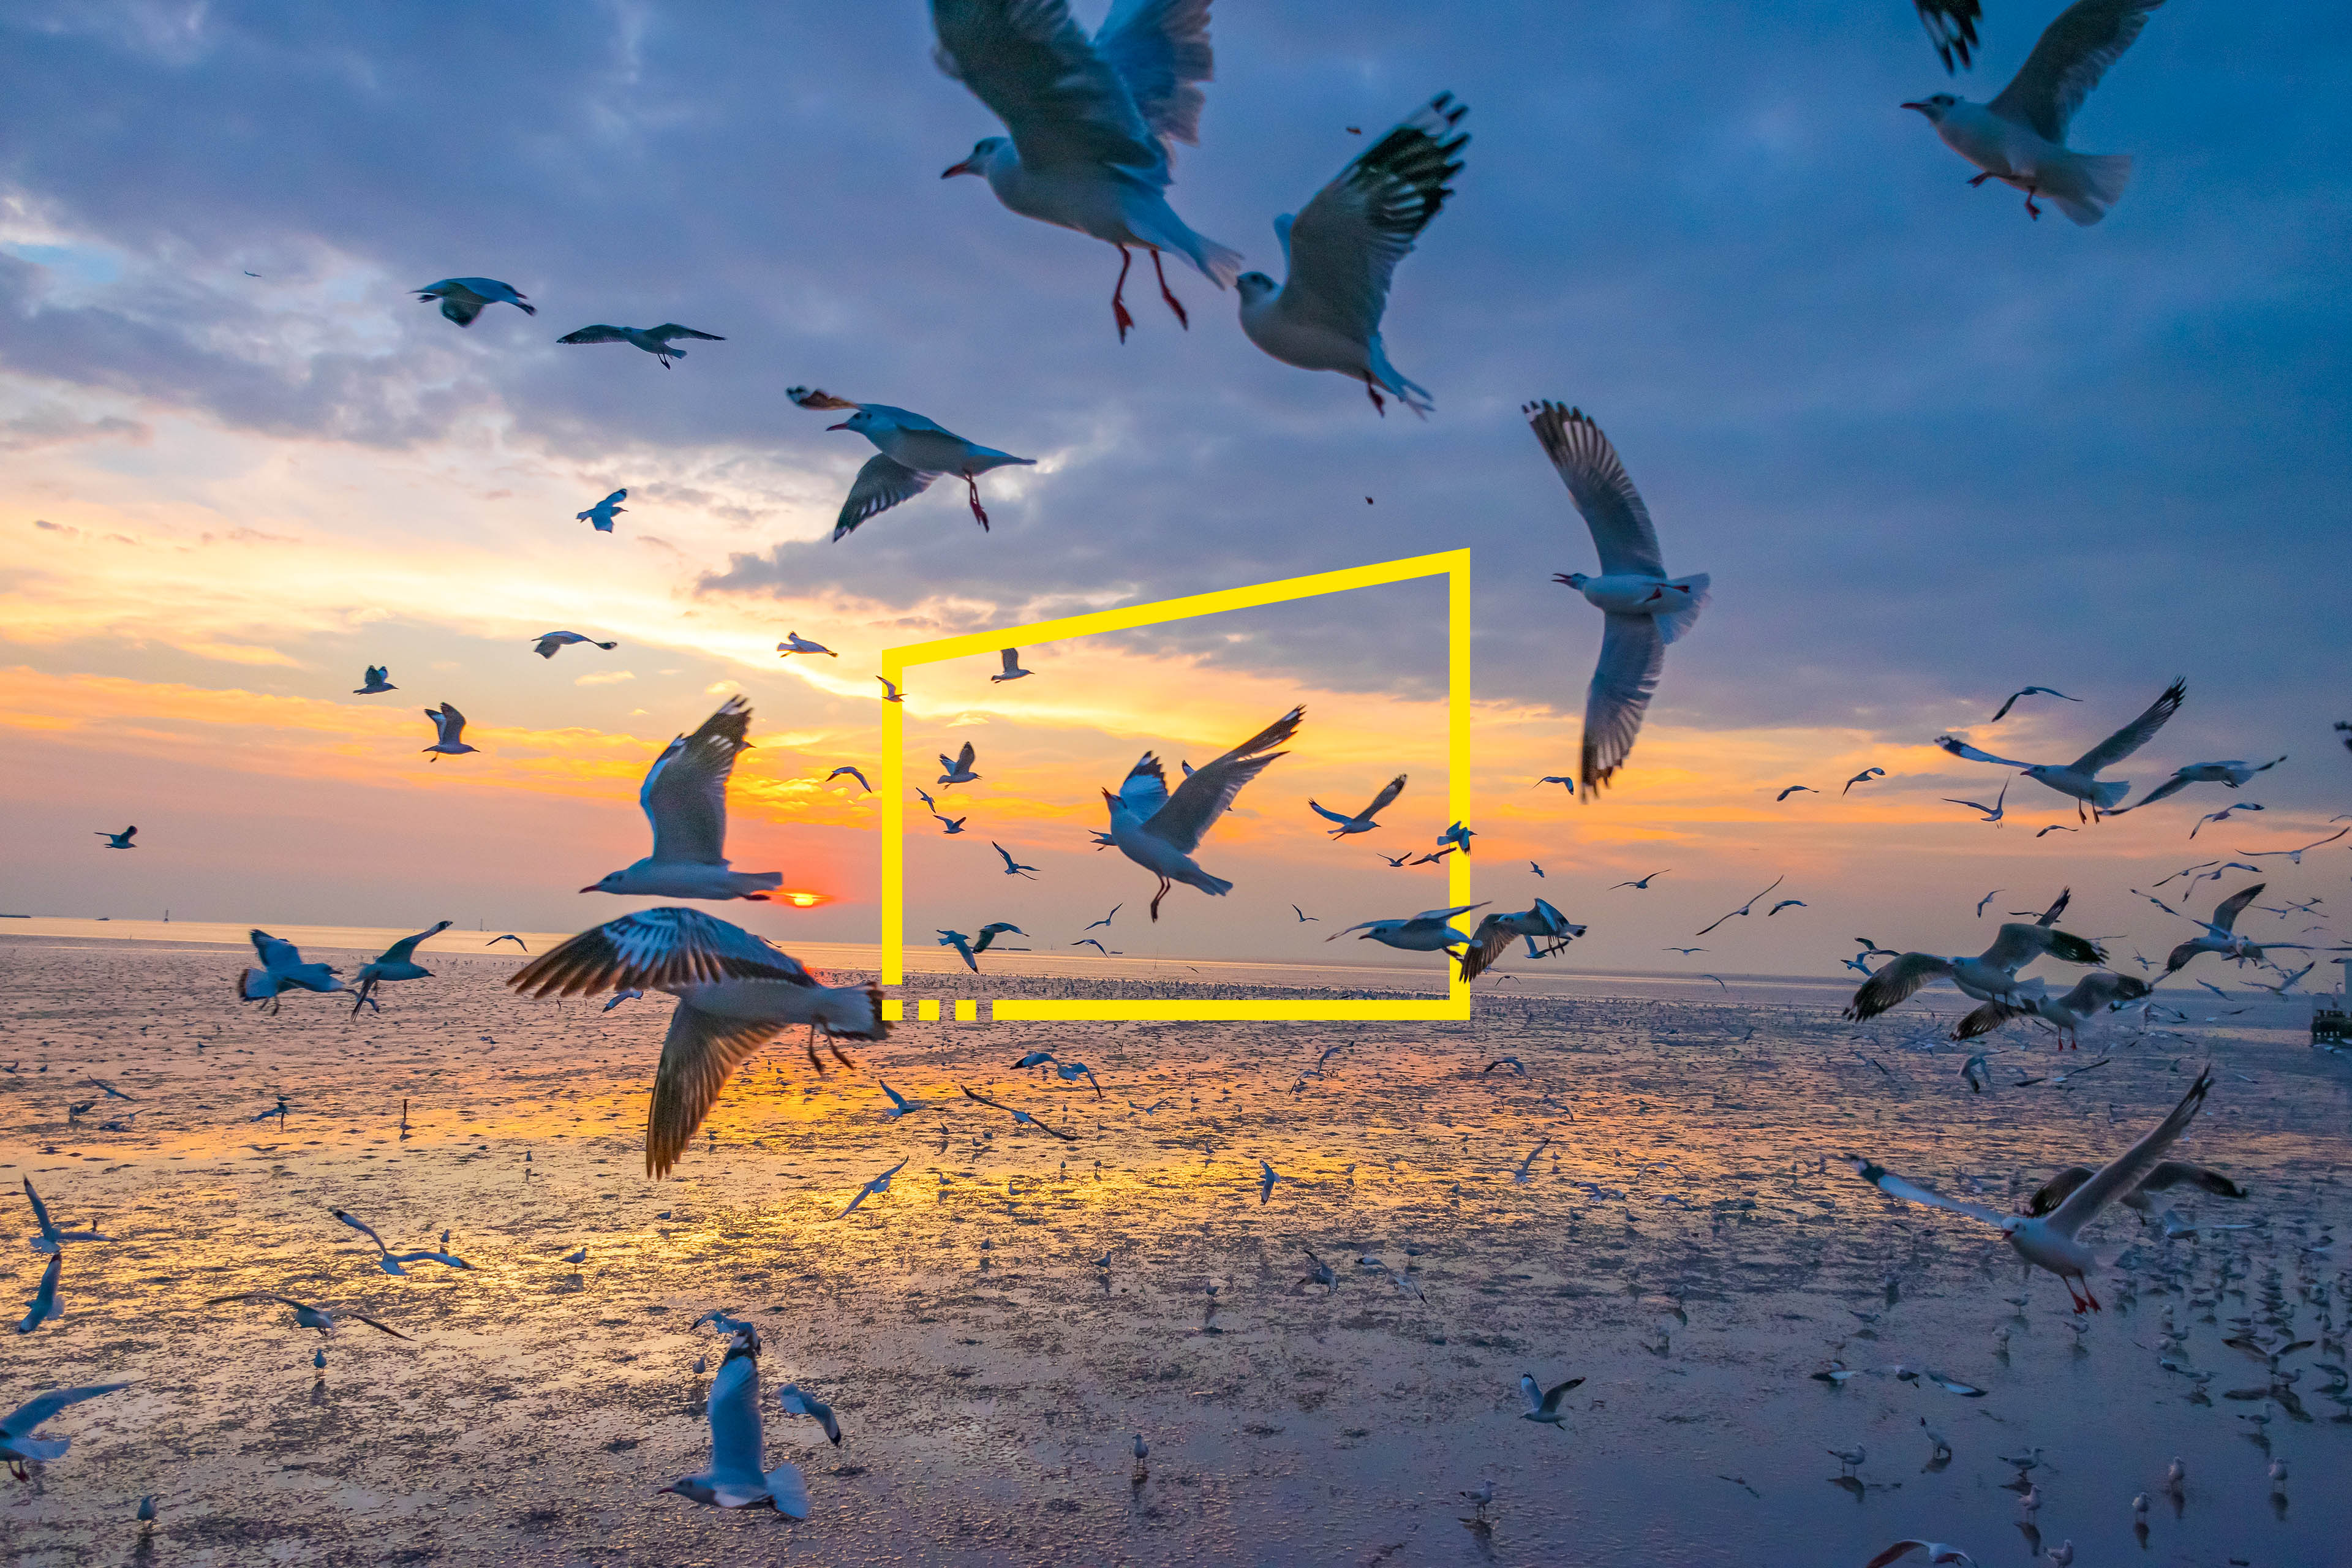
[932,0,1166,188]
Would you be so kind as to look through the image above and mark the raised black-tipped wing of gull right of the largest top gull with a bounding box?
[1277,94,1470,343]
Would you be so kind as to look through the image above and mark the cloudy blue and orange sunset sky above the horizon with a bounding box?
[0,0,2352,973]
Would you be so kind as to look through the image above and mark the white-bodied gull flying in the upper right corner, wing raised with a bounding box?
[1903,0,2164,225]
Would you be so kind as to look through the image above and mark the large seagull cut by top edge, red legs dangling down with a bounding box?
[932,0,1242,343]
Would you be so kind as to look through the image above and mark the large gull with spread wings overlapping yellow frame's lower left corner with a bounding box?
[506,907,889,1178]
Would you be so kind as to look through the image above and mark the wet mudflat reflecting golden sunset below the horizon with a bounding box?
[0,933,2352,1566]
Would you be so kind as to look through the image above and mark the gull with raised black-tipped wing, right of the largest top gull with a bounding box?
[1232,92,1470,418]
